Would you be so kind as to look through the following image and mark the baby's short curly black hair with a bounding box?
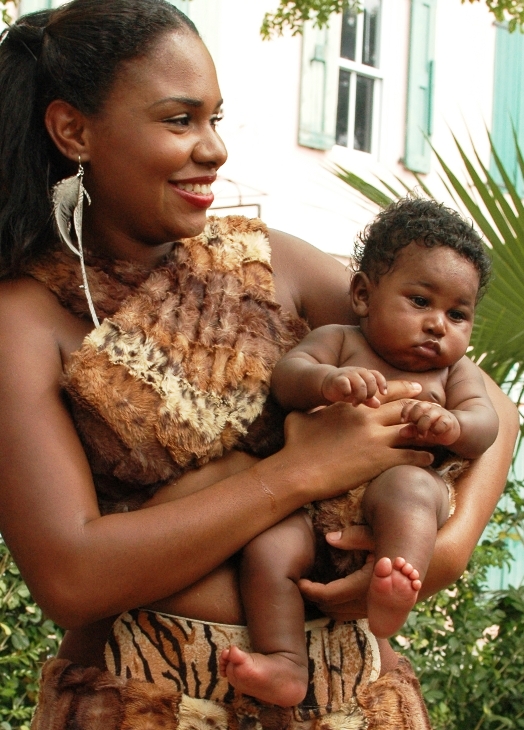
[353,196,491,302]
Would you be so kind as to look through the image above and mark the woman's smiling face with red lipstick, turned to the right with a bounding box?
[84,31,227,263]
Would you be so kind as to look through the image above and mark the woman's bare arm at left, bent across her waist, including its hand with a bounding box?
[0,281,430,627]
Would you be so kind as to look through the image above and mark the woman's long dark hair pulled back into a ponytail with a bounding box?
[0,0,198,278]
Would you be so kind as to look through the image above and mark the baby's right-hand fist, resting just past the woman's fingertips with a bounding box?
[400,400,460,446]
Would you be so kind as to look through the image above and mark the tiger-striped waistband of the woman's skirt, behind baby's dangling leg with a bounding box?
[106,610,380,727]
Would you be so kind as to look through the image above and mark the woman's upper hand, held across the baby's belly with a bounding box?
[280,381,433,501]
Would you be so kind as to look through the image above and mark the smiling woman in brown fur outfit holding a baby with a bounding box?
[0,0,517,730]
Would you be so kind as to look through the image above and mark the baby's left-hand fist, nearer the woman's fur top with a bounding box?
[322,367,387,408]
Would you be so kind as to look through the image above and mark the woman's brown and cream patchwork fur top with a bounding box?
[28,216,308,512]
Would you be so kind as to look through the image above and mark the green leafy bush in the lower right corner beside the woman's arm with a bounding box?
[396,482,524,730]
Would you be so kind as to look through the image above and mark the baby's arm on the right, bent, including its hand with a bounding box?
[402,357,499,459]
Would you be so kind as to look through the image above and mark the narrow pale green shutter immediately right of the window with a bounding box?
[404,0,437,172]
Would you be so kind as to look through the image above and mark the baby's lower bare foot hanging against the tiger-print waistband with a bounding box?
[219,646,308,707]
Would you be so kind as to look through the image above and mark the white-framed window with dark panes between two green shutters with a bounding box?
[335,0,381,152]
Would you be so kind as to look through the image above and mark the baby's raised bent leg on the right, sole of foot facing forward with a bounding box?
[362,465,449,637]
